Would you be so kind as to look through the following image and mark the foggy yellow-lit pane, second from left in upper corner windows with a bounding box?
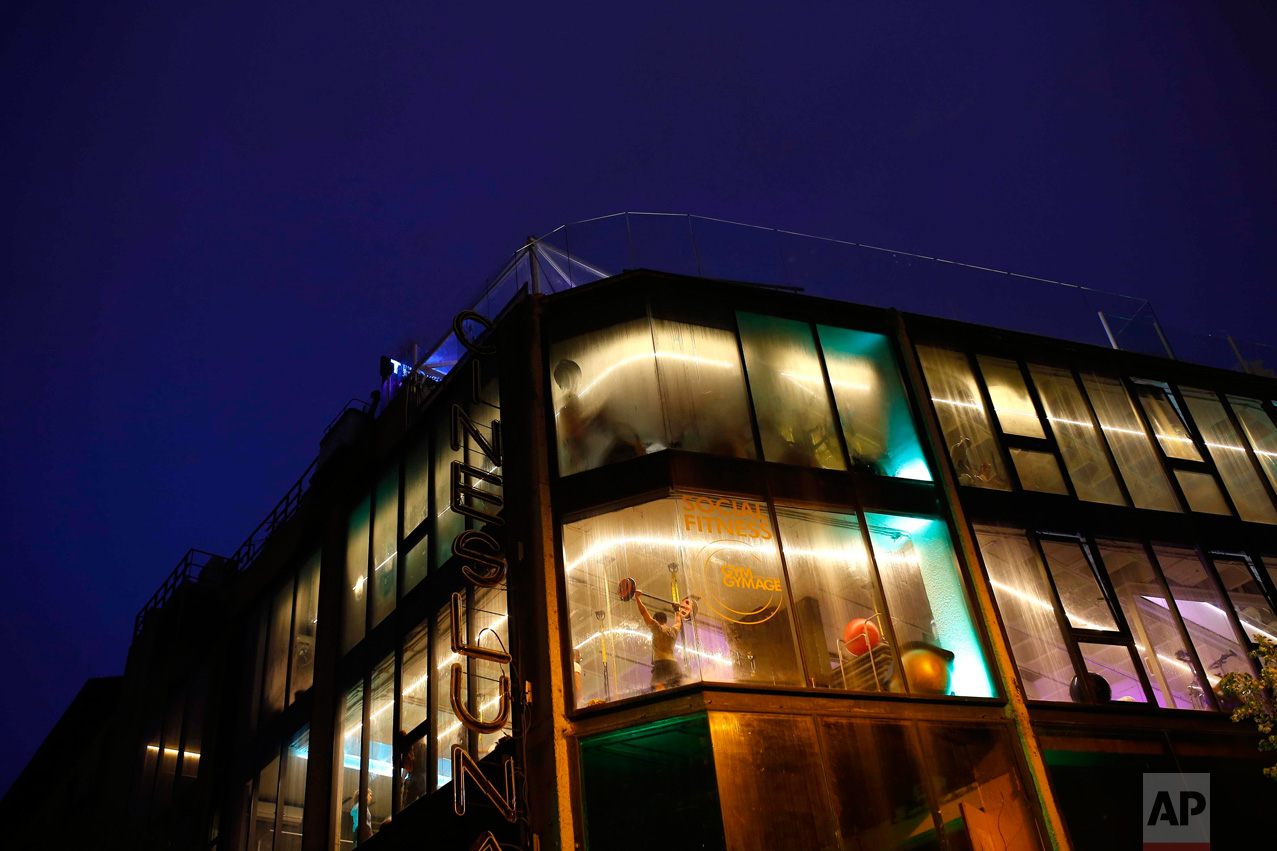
[653,319,756,457]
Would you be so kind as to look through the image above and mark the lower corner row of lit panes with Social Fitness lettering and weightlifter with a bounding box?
[563,495,994,707]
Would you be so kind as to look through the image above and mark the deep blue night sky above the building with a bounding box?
[0,0,1277,790]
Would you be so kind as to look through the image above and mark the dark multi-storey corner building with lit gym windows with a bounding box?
[4,261,1277,851]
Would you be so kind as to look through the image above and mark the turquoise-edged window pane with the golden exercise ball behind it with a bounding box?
[866,514,994,698]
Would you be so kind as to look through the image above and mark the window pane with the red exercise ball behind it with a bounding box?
[776,507,902,691]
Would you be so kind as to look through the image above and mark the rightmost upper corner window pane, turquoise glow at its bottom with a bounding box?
[807,325,931,482]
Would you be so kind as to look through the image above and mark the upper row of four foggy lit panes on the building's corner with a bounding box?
[549,306,931,482]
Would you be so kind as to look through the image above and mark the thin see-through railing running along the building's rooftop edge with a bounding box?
[134,212,1277,635]
